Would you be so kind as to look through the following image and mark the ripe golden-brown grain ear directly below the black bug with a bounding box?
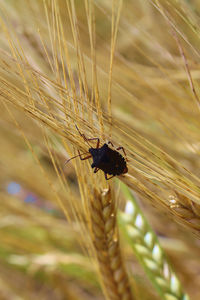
[90,189,134,300]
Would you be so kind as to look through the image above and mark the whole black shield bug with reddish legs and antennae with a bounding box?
[66,126,128,180]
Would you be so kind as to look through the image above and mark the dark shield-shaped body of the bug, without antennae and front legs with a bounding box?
[89,144,128,180]
